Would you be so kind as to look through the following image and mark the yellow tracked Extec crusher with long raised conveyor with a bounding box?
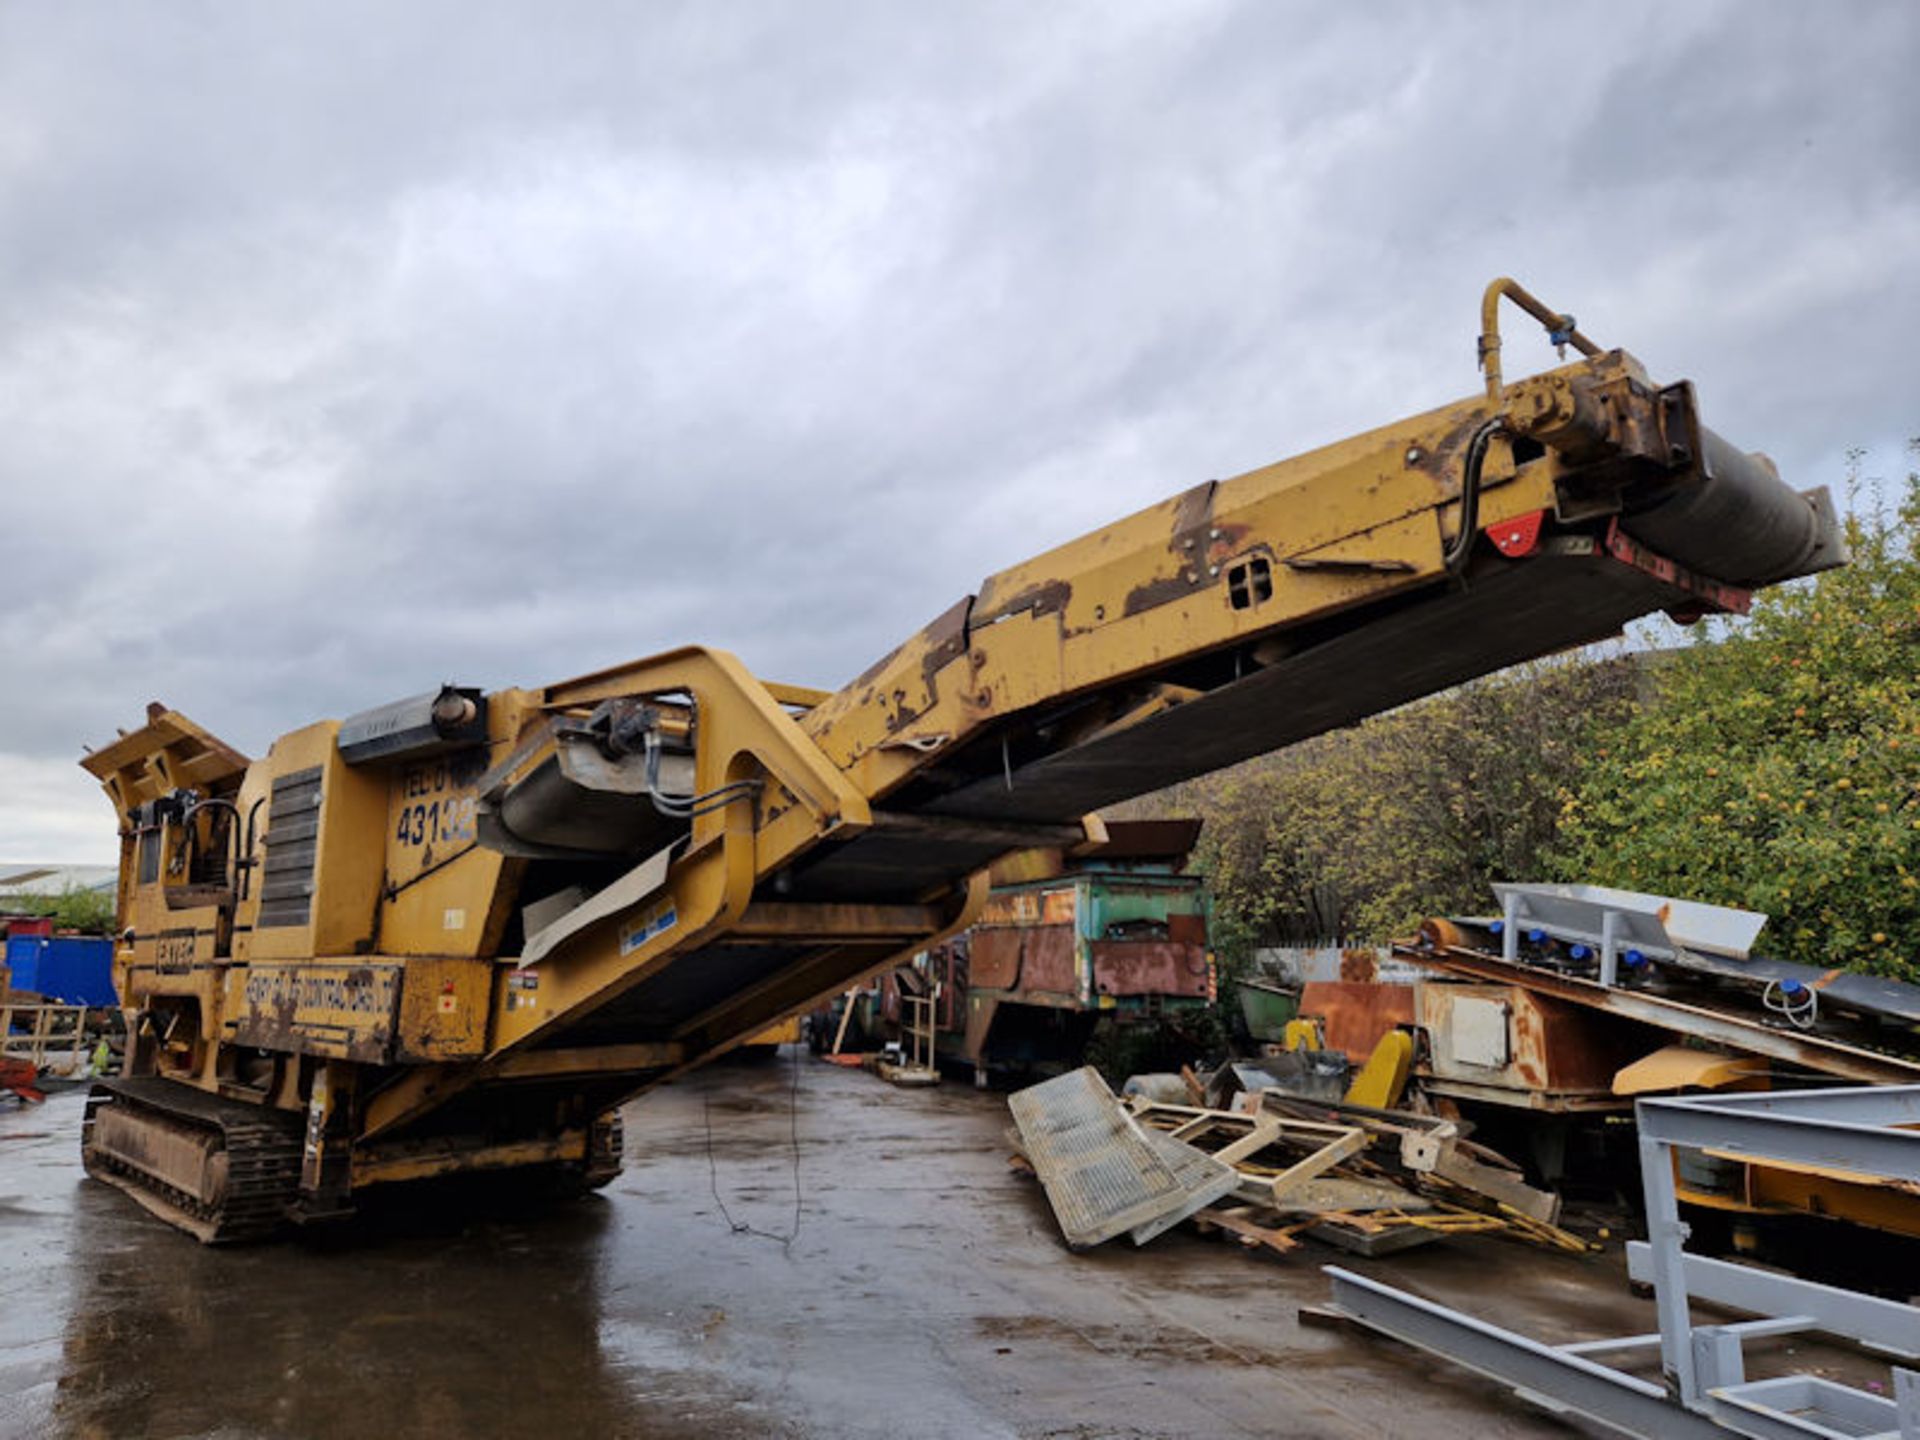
[83,282,1843,1240]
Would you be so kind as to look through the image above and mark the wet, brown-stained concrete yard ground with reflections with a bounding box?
[0,1056,1681,1440]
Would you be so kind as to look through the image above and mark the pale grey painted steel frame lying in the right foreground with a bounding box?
[1327,1085,1920,1440]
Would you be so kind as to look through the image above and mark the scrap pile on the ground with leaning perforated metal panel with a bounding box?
[1008,1066,1594,1256]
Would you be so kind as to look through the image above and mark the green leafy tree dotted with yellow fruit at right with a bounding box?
[1557,453,1920,979]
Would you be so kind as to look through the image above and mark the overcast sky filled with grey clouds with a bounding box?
[0,0,1920,862]
